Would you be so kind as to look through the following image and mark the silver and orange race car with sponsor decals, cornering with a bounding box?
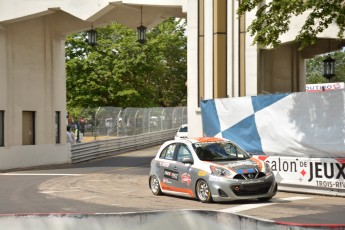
[149,137,277,203]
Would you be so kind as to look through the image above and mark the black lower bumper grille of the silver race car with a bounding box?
[231,182,272,196]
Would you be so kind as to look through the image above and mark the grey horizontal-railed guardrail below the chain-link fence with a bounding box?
[71,129,177,163]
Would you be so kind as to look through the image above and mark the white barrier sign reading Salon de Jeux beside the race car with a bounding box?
[255,155,345,196]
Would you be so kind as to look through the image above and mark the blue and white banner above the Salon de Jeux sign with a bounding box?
[200,89,345,158]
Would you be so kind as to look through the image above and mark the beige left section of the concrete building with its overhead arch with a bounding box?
[0,0,186,170]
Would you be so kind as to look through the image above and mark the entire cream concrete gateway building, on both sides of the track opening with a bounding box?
[0,0,341,170]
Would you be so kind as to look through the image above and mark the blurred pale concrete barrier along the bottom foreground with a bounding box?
[0,210,334,230]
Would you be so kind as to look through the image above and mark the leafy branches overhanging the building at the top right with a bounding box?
[238,0,345,49]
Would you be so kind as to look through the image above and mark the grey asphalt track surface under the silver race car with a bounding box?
[0,146,345,226]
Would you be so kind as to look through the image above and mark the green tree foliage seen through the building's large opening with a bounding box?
[66,18,187,117]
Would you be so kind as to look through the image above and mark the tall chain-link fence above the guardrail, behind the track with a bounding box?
[69,107,187,142]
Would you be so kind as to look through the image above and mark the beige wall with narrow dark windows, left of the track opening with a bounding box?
[0,16,70,170]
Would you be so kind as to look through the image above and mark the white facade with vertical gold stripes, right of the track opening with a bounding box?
[187,0,344,137]
